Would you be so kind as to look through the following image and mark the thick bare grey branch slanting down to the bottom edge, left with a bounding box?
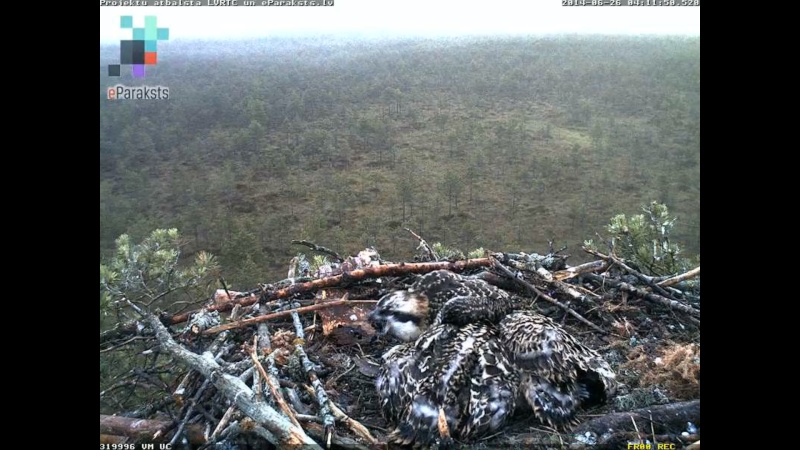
[144,314,320,449]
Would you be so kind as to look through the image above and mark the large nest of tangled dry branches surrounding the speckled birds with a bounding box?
[100,239,700,449]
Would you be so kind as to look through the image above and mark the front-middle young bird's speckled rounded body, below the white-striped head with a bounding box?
[377,324,519,446]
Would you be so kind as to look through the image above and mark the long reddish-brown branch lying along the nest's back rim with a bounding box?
[164,258,492,325]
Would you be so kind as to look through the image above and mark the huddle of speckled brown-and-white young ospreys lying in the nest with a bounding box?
[370,270,616,446]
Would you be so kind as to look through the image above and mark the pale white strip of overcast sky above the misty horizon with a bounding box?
[100,0,700,43]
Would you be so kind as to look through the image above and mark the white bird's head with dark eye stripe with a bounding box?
[369,291,429,342]
